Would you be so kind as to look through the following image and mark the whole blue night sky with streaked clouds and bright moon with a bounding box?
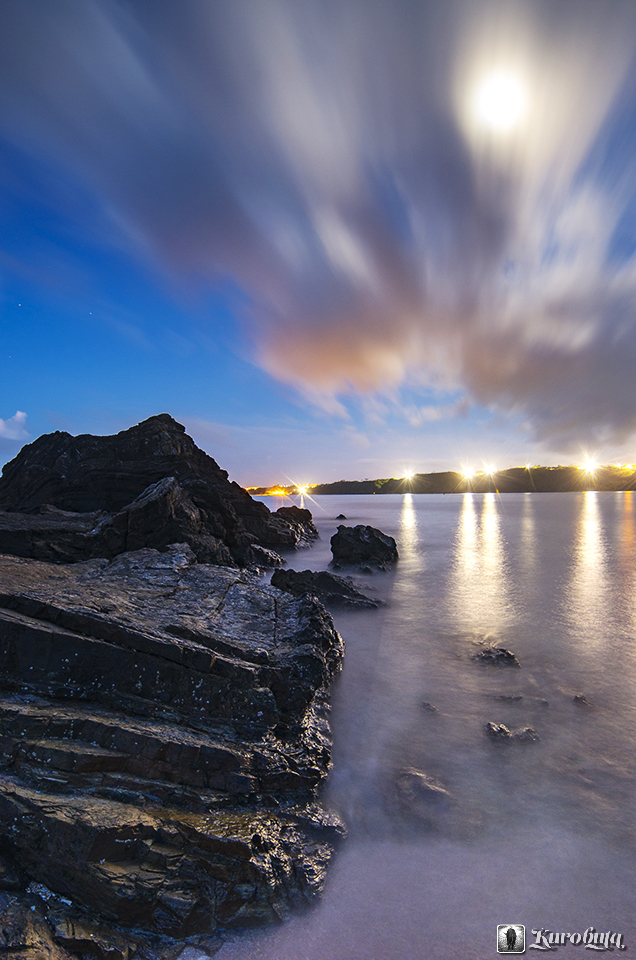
[0,0,636,484]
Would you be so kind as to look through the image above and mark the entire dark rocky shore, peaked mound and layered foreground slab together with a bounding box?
[0,415,344,960]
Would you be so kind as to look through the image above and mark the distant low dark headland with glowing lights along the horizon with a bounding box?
[247,463,636,497]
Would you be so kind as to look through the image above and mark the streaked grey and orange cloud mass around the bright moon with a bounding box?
[0,0,636,448]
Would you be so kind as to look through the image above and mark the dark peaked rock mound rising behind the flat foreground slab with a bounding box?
[0,414,318,566]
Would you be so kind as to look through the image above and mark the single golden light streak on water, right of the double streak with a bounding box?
[566,490,609,643]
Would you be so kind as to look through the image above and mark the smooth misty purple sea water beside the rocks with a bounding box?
[206,492,636,960]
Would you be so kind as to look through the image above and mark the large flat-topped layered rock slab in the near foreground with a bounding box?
[0,544,343,960]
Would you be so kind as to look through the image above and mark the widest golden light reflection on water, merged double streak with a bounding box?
[448,493,510,633]
